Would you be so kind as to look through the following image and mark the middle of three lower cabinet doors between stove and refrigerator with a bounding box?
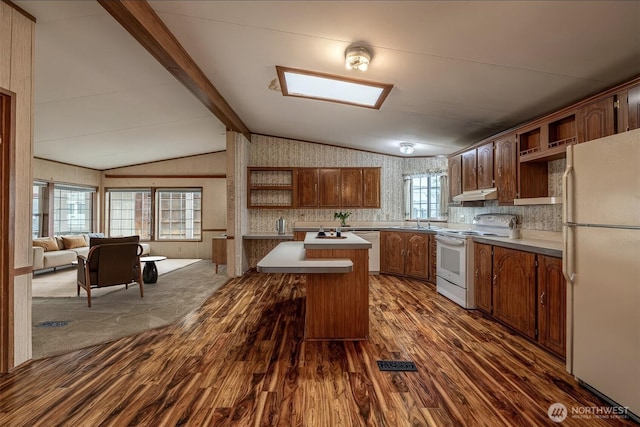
[493,246,536,339]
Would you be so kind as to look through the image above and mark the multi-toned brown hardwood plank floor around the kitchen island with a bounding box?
[0,273,635,427]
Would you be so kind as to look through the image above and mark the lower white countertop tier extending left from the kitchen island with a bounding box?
[257,242,353,273]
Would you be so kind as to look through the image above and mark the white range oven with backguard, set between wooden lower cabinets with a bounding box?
[436,214,516,309]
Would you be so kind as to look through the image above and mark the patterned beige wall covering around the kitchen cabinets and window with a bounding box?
[248,135,566,232]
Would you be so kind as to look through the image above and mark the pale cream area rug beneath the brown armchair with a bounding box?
[32,258,200,300]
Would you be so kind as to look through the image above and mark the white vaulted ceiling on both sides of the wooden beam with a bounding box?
[14,0,640,170]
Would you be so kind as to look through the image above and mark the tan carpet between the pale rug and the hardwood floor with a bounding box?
[32,260,228,359]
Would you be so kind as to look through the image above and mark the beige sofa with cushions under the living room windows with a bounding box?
[32,234,151,271]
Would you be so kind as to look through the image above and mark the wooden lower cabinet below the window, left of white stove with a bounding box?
[380,231,435,281]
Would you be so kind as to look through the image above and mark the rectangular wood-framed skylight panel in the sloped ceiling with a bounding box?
[276,66,393,110]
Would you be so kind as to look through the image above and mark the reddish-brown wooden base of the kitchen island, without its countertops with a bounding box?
[304,249,369,340]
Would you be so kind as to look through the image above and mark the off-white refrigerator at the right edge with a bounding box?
[563,129,640,417]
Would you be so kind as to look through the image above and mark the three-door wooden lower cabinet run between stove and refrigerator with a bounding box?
[474,243,567,358]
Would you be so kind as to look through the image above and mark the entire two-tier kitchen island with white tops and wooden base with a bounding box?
[257,232,371,340]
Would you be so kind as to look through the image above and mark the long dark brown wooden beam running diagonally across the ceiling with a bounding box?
[98,0,251,140]
